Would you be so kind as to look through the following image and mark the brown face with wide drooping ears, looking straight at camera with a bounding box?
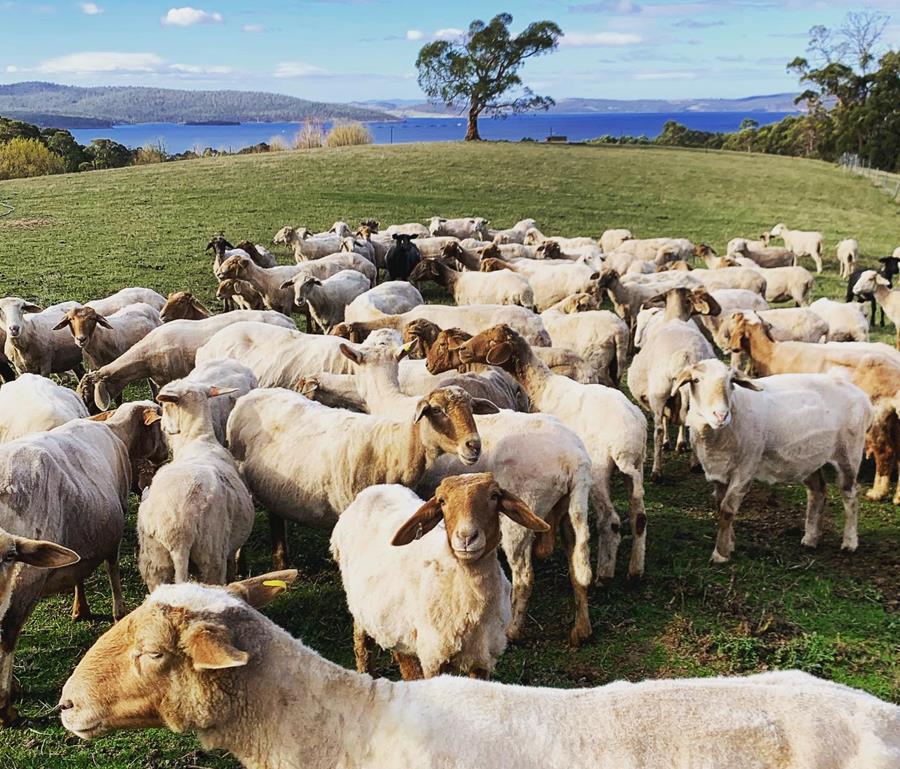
[392,473,550,562]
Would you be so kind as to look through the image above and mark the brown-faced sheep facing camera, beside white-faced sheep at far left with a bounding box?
[53,302,162,370]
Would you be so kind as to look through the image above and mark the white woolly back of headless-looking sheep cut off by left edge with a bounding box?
[0,374,88,443]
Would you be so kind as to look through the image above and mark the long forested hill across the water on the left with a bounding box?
[0,82,390,124]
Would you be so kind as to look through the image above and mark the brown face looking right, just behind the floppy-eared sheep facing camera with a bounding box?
[415,387,499,465]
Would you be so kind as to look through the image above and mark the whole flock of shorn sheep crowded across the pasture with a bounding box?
[0,217,900,769]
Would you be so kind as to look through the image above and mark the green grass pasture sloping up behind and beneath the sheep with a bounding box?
[0,144,900,769]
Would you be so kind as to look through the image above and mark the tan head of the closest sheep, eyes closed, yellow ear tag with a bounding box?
[59,571,297,740]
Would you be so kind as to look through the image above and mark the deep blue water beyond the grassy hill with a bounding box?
[72,112,788,153]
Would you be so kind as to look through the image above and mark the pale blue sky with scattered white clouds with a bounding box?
[0,0,900,101]
